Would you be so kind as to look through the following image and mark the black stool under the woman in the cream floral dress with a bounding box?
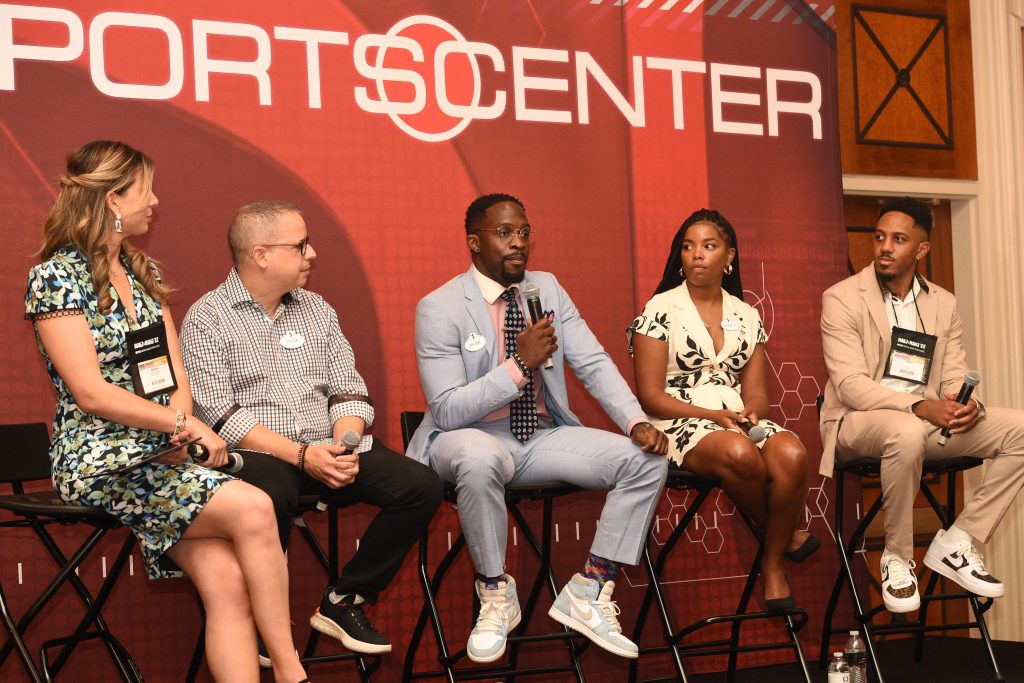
[629,464,811,683]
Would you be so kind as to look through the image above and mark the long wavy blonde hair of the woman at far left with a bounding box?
[36,140,172,313]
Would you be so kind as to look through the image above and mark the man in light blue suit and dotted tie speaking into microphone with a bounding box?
[408,195,668,661]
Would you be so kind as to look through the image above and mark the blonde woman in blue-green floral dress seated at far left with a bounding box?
[26,141,305,683]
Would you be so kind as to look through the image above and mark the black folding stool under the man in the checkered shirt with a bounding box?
[185,473,381,683]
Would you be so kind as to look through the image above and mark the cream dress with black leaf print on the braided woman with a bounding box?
[627,283,787,465]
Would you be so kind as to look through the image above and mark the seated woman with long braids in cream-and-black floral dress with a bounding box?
[630,209,820,611]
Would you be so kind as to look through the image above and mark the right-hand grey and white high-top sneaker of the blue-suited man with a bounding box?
[548,573,639,659]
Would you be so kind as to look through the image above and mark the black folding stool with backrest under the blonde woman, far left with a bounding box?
[0,422,142,683]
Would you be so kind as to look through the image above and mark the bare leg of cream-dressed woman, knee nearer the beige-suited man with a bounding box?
[761,432,807,598]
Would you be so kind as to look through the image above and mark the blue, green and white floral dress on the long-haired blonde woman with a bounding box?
[25,248,231,579]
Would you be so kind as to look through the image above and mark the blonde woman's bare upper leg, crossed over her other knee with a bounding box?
[171,481,305,683]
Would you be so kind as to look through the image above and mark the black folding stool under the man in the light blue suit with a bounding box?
[401,413,590,683]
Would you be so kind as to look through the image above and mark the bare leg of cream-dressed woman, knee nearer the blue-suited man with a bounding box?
[683,431,790,599]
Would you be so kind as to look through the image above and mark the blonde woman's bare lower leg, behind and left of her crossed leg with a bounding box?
[167,539,259,682]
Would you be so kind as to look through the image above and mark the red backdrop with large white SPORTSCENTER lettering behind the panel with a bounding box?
[0,0,846,681]
